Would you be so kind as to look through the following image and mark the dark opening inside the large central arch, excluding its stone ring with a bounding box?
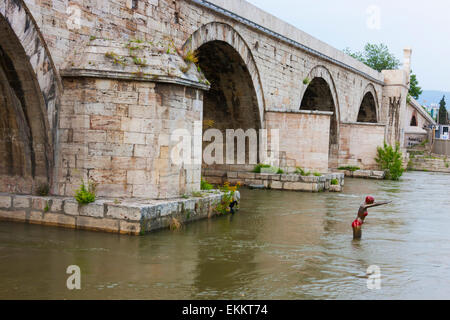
[195,40,261,171]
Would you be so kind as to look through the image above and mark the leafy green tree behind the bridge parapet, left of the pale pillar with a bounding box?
[344,43,400,72]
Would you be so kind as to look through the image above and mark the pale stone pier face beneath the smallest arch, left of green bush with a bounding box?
[339,123,385,169]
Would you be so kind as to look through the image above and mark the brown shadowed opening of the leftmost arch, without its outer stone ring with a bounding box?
[0,6,55,193]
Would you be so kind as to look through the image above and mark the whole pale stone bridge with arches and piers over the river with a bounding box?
[0,0,411,199]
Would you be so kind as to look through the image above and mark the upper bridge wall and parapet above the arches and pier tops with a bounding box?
[25,0,383,121]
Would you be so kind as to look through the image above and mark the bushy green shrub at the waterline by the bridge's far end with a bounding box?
[375,142,405,181]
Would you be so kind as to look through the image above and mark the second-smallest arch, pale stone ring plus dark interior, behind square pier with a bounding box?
[300,65,340,167]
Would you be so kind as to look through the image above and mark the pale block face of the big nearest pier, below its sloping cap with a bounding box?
[57,78,202,199]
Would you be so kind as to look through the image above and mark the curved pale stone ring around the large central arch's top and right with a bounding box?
[183,22,265,128]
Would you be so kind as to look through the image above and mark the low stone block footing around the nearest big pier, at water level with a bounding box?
[0,191,223,235]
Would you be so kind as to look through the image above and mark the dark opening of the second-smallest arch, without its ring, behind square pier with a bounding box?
[300,77,339,168]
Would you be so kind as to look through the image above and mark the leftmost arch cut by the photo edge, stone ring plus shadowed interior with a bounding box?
[0,0,61,193]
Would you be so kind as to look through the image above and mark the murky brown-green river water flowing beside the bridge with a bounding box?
[0,172,450,299]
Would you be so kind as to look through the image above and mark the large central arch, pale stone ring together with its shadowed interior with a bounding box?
[183,22,265,170]
